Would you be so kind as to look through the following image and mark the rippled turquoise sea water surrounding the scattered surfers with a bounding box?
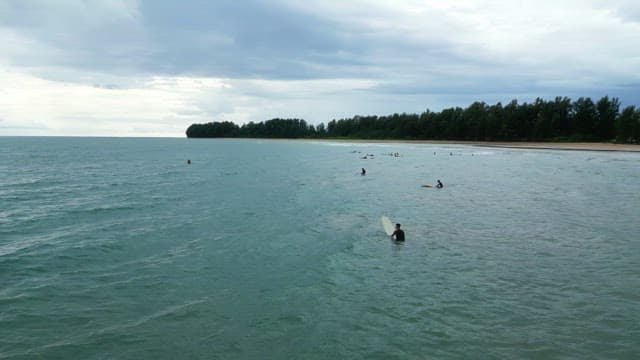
[0,137,640,359]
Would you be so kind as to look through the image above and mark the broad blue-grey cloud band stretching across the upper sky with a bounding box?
[0,0,640,112]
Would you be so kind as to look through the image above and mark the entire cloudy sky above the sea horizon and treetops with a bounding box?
[0,0,640,136]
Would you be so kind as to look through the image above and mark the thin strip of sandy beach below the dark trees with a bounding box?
[290,139,640,153]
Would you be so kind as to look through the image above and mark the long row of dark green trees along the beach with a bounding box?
[187,96,640,143]
